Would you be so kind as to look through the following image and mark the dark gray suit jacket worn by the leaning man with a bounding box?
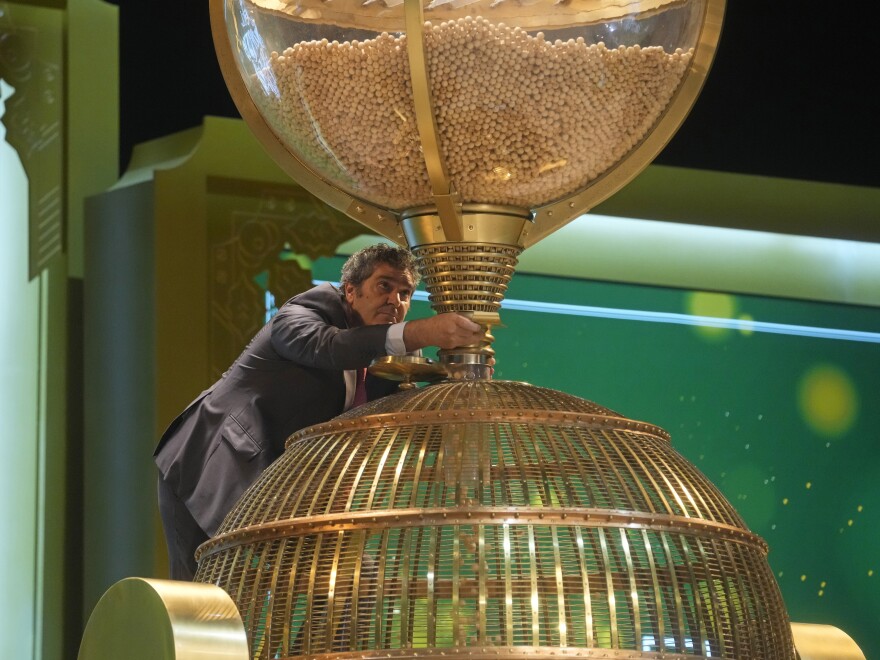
[154,284,397,536]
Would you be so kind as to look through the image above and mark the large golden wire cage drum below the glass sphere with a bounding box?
[196,380,796,660]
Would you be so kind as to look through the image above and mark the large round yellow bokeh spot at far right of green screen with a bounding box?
[798,364,859,437]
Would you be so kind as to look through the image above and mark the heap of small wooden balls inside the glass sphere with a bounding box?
[263,17,692,209]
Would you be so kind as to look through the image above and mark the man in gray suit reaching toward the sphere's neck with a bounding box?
[154,244,483,580]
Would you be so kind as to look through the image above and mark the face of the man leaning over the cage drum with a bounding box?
[345,263,414,325]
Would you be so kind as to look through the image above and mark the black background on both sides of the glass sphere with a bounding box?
[112,0,880,187]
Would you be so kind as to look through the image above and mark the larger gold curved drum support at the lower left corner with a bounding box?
[78,578,250,660]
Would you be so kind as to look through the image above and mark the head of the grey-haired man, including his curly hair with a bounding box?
[340,243,418,325]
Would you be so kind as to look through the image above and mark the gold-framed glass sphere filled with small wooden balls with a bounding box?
[212,0,723,233]
